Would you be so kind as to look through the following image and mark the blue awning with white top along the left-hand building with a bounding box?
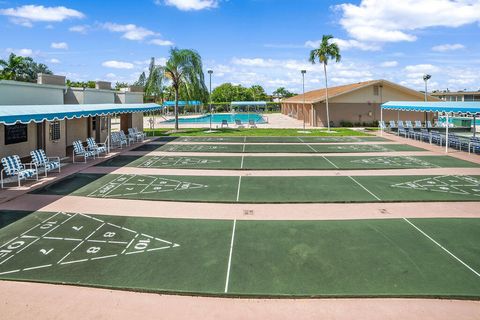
[0,103,164,125]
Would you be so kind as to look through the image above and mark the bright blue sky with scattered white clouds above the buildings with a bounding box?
[0,0,480,93]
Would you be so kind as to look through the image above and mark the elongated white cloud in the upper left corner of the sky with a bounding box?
[0,5,85,27]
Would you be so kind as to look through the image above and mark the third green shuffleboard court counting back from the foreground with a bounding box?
[97,155,480,170]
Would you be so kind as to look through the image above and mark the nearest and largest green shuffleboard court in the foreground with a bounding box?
[0,212,480,299]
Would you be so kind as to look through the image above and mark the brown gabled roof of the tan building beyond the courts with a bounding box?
[282,80,438,103]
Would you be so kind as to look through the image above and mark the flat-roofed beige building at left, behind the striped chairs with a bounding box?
[0,74,143,158]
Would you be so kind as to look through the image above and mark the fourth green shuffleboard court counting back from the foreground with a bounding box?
[144,143,425,153]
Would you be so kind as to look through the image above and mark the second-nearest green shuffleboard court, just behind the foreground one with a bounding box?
[33,174,480,203]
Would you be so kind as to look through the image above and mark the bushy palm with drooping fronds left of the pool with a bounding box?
[161,48,207,130]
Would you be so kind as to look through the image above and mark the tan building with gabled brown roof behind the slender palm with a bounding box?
[281,80,439,127]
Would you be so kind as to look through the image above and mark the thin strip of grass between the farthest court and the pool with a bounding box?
[144,128,369,137]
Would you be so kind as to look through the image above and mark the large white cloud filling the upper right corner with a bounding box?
[335,0,480,42]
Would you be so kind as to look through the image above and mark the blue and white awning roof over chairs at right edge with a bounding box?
[382,101,480,115]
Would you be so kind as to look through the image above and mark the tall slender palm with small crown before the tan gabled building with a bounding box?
[309,35,342,131]
